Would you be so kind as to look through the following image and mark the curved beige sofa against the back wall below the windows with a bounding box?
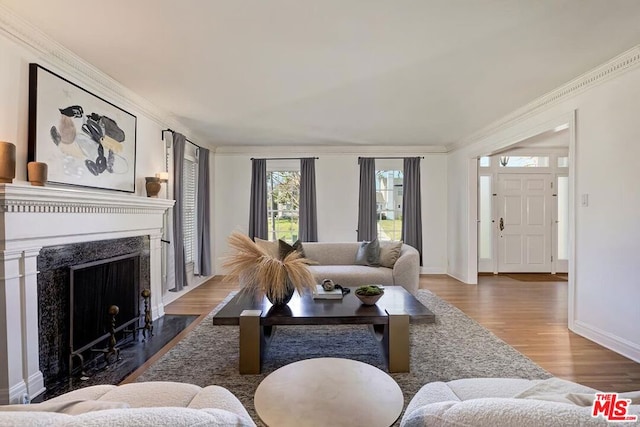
[302,242,420,294]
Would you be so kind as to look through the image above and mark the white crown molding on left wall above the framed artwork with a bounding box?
[0,4,198,141]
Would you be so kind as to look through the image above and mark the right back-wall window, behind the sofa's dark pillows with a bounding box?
[376,169,404,240]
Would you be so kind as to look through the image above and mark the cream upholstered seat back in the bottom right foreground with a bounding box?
[400,378,640,427]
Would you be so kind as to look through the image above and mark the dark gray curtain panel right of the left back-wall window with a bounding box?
[298,157,318,242]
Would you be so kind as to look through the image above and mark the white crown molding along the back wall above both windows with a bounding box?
[215,145,447,157]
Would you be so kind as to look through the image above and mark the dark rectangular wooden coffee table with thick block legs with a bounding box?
[213,286,435,374]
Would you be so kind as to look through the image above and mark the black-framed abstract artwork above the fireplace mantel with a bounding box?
[28,64,137,193]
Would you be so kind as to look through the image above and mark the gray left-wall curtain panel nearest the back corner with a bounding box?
[195,148,211,276]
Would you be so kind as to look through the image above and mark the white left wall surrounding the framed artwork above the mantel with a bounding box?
[0,32,214,303]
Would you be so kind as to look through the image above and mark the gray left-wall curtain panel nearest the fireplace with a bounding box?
[169,132,187,292]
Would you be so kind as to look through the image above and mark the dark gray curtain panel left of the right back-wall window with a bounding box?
[358,157,378,242]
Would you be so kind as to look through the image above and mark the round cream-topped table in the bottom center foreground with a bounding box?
[254,357,404,427]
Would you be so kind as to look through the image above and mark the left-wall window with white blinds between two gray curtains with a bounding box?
[182,144,198,264]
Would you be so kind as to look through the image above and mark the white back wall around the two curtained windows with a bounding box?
[214,151,447,274]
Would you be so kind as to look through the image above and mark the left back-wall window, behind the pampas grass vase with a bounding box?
[267,171,300,243]
